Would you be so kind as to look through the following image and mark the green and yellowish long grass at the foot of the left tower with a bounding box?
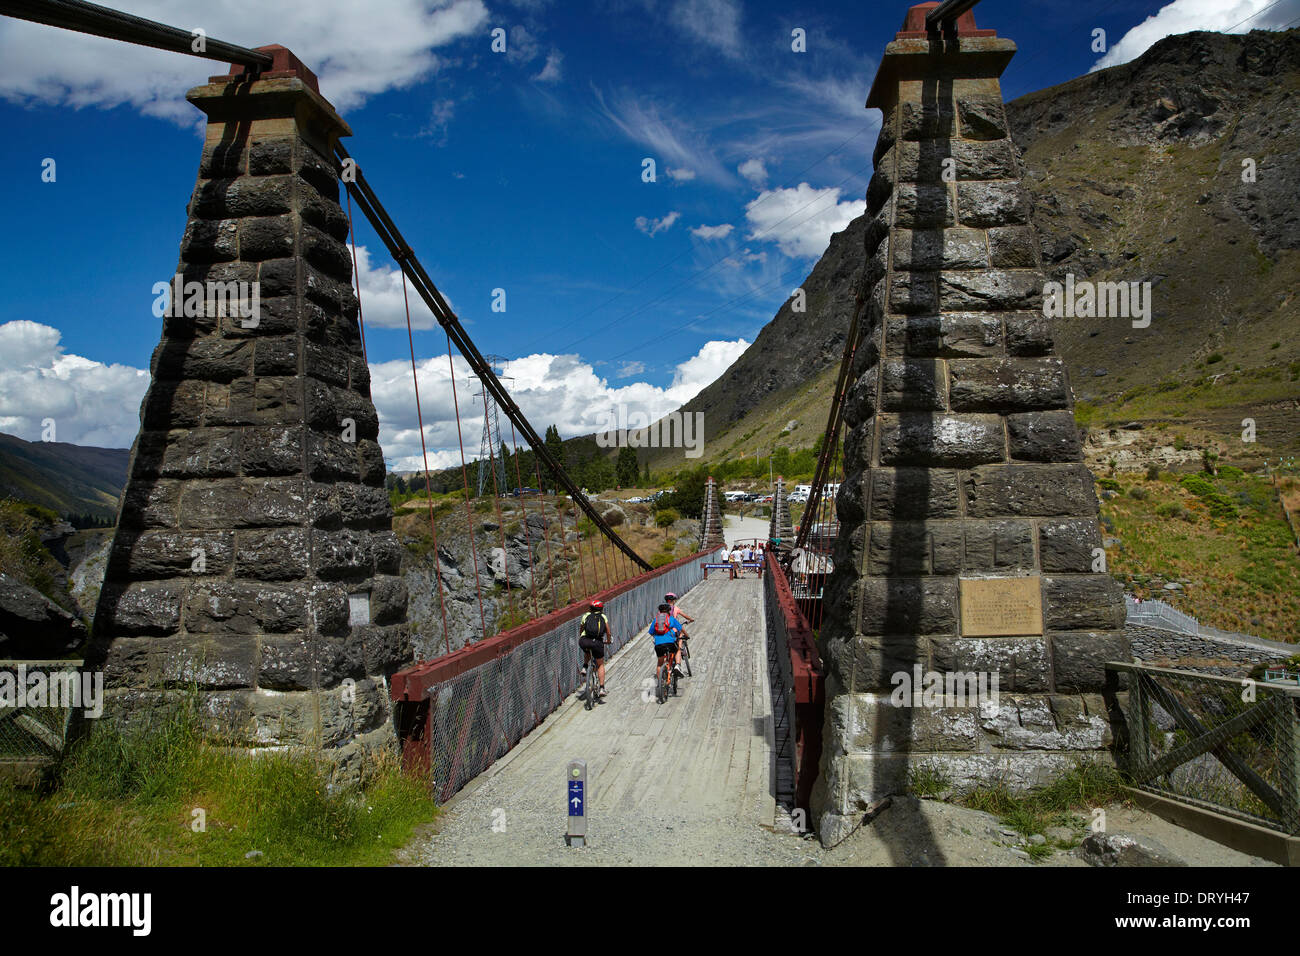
[0,700,437,866]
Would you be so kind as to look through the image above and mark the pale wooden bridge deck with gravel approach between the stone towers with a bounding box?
[417,574,776,865]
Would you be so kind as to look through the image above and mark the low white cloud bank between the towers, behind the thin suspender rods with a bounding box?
[371,339,749,471]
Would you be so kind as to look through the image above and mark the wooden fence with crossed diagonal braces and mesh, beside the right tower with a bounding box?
[1106,663,1300,835]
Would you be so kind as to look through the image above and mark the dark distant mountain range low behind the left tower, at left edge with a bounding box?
[0,432,131,520]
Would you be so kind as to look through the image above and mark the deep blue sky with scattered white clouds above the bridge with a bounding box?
[0,0,1300,467]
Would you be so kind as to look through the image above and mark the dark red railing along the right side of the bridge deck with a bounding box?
[763,551,826,810]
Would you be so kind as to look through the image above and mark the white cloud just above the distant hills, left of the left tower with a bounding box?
[0,320,150,449]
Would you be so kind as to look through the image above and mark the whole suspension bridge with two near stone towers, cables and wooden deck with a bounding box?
[0,0,1295,863]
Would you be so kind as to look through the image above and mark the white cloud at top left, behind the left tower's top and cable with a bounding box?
[0,0,488,125]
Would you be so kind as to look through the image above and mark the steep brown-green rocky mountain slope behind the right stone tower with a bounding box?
[651,30,1300,476]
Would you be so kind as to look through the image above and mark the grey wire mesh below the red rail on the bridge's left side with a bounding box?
[417,554,714,803]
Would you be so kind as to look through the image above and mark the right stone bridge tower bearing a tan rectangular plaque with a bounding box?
[813,3,1128,844]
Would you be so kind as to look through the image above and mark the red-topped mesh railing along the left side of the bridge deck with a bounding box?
[390,550,719,803]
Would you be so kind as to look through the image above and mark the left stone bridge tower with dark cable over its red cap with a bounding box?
[92,47,410,775]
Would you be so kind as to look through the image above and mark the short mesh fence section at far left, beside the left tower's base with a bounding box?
[0,661,88,765]
